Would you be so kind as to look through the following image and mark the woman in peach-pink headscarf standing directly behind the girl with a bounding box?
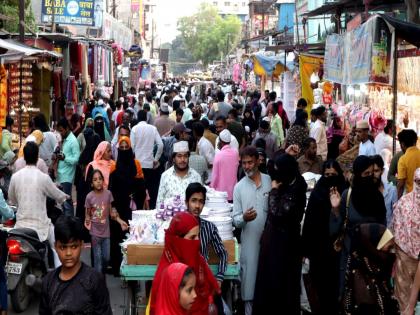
[85,141,115,189]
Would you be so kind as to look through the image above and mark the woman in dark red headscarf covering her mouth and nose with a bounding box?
[150,212,220,315]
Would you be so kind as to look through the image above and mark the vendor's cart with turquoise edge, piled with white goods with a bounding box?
[120,188,240,314]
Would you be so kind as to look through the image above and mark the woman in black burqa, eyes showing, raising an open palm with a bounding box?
[302,160,346,315]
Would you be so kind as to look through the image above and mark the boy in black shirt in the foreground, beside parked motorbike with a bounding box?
[38,215,112,315]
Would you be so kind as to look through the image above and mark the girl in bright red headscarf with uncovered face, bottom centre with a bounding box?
[156,263,197,315]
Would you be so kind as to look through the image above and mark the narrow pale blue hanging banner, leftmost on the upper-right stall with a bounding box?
[324,34,344,83]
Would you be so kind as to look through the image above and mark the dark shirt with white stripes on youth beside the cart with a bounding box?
[199,218,227,281]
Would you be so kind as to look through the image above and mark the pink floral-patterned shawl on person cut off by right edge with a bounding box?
[392,168,420,259]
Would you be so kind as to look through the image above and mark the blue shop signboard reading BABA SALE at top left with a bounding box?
[41,0,96,26]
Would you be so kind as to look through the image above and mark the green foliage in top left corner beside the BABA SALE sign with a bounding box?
[0,0,35,33]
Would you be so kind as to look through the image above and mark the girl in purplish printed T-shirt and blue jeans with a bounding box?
[85,170,128,273]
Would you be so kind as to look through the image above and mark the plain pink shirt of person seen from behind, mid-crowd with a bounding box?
[210,145,239,200]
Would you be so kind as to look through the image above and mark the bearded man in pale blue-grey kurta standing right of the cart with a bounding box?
[233,147,271,315]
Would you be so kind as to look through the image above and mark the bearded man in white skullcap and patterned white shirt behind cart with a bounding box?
[156,141,201,208]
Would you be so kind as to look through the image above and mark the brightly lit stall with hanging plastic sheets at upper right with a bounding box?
[323,15,420,150]
